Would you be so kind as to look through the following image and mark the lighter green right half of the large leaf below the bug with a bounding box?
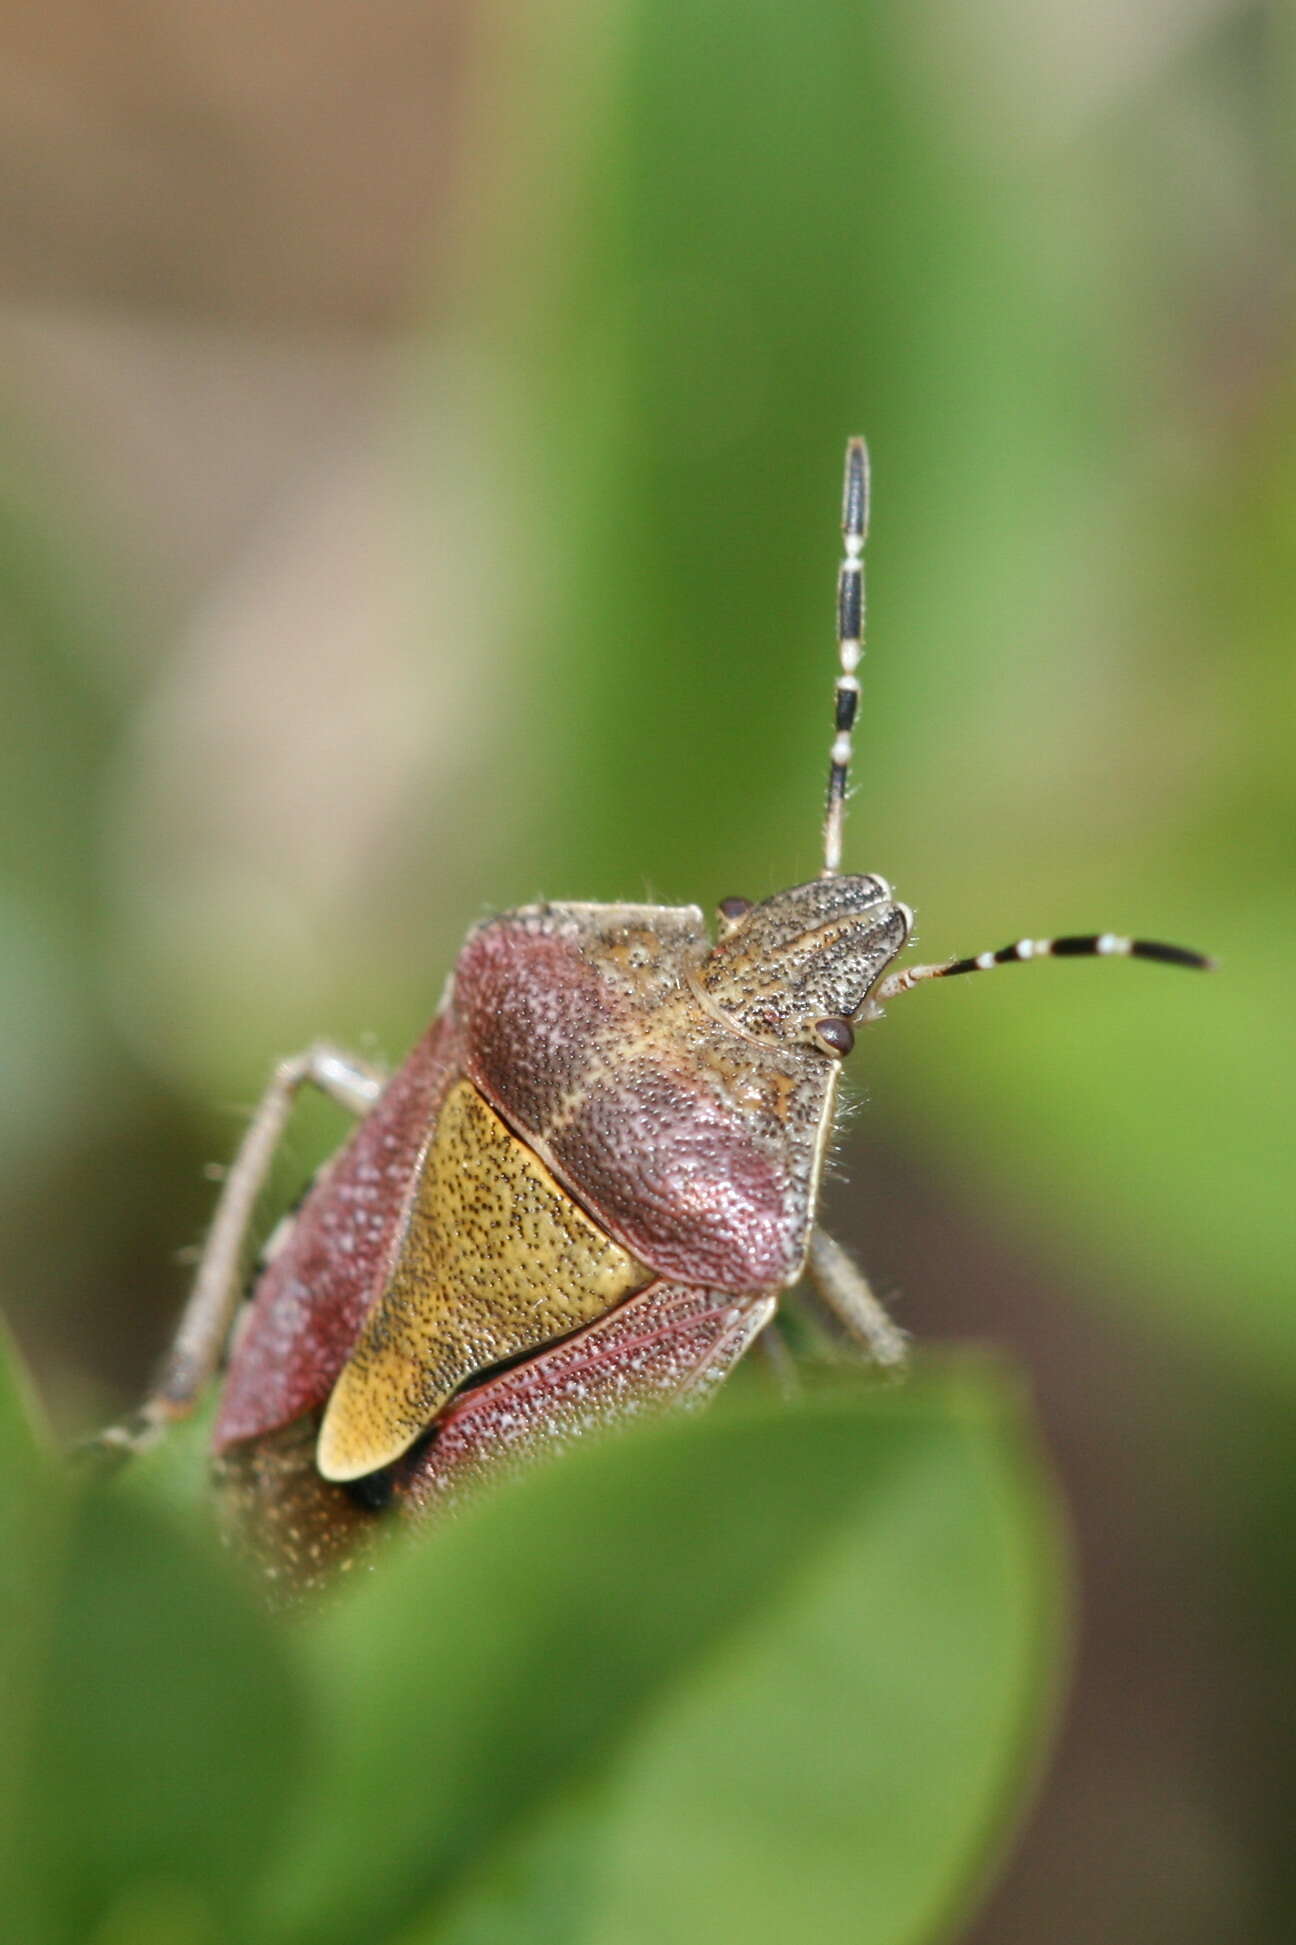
[588,1391,1057,1945]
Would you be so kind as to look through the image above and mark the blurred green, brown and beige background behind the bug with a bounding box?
[0,0,1296,1945]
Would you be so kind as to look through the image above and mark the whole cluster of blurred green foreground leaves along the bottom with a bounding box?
[0,1330,1059,1945]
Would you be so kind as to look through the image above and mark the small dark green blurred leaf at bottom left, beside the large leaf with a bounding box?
[27,1488,311,1945]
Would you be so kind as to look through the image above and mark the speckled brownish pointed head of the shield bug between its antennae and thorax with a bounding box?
[697,875,913,1058]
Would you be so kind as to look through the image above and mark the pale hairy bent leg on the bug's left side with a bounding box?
[88,1043,385,1465]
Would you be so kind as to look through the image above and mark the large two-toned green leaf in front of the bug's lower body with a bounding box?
[262,1377,1057,1945]
